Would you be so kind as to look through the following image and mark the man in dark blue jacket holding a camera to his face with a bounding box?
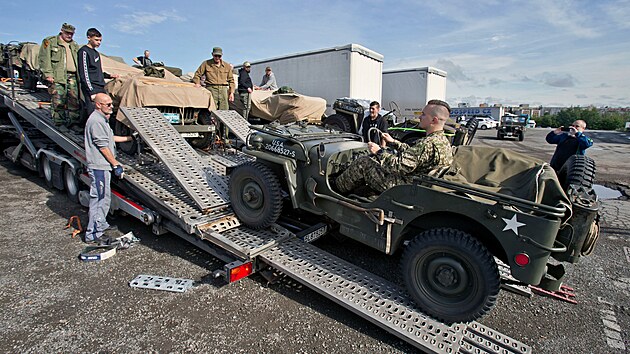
[545,119,593,171]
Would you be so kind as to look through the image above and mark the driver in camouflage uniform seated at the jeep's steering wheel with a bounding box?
[333,100,453,193]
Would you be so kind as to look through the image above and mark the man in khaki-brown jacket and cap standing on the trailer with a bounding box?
[193,47,235,110]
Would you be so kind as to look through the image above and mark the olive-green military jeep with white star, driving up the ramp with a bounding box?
[229,124,599,323]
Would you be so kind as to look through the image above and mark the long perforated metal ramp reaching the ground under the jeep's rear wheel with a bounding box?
[259,239,531,353]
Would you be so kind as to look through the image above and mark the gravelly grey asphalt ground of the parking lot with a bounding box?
[0,128,630,353]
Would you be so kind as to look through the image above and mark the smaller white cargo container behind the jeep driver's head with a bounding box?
[381,67,446,124]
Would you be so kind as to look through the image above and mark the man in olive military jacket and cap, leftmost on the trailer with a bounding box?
[39,23,80,127]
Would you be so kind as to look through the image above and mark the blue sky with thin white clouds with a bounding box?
[0,0,630,107]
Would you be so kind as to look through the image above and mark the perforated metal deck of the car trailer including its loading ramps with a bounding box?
[0,83,531,353]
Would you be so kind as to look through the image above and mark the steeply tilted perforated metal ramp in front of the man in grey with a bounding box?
[119,107,229,213]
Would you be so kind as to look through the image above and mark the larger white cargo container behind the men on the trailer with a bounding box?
[250,44,383,115]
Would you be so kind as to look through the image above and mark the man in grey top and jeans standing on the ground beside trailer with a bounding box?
[85,93,133,243]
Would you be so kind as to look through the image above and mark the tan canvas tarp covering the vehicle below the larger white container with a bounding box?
[230,91,326,124]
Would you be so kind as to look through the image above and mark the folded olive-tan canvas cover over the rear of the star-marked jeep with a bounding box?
[442,146,571,208]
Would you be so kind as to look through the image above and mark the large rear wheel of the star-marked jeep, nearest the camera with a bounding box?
[401,229,500,324]
